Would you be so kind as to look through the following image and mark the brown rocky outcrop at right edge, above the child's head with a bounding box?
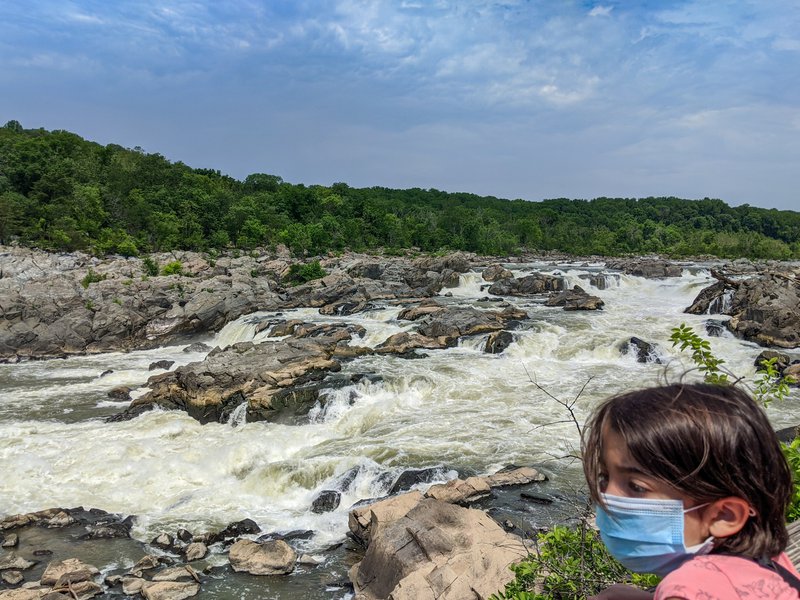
[686,269,800,348]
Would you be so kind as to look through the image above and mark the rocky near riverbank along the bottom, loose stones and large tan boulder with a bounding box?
[0,468,545,600]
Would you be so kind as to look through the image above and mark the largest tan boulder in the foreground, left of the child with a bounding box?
[350,498,528,600]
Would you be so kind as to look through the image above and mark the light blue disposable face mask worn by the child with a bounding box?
[595,494,714,577]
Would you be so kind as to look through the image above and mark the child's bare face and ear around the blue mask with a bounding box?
[598,427,709,546]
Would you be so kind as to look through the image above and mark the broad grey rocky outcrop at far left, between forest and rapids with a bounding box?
[0,248,279,361]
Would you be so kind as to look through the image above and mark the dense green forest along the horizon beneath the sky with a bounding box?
[0,121,800,259]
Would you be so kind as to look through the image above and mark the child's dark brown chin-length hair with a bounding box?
[582,384,792,558]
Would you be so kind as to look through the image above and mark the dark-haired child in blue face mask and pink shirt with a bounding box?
[583,384,800,600]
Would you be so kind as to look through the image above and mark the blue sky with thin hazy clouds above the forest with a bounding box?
[0,0,800,210]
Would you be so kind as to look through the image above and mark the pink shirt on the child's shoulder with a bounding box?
[654,552,800,600]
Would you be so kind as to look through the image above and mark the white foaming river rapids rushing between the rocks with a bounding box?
[0,263,800,598]
